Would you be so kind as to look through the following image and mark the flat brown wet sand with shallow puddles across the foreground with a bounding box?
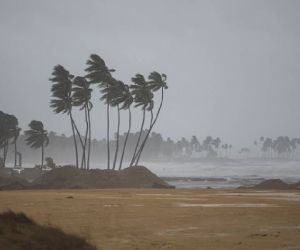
[0,189,300,250]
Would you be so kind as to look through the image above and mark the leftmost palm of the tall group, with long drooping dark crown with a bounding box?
[49,65,83,168]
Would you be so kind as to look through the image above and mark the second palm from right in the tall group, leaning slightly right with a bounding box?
[130,74,154,166]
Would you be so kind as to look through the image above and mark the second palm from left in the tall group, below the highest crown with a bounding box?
[72,76,93,169]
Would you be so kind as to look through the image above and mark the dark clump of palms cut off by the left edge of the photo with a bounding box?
[0,111,21,167]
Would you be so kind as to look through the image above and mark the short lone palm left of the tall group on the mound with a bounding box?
[25,120,49,167]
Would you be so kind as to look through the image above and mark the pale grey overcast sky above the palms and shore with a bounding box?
[0,0,300,146]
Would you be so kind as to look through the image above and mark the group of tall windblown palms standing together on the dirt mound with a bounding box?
[50,54,167,170]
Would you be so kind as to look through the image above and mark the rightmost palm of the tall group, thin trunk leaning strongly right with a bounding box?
[136,71,168,165]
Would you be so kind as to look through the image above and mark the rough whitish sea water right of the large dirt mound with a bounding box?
[147,160,300,188]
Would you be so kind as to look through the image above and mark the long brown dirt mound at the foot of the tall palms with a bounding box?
[32,166,174,189]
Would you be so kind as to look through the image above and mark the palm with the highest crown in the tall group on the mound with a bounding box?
[85,54,115,169]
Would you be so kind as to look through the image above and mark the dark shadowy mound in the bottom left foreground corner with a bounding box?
[0,211,96,250]
